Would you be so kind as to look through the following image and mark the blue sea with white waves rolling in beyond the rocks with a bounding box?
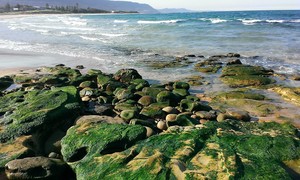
[0,10,300,79]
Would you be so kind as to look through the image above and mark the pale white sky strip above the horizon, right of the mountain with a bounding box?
[119,0,300,10]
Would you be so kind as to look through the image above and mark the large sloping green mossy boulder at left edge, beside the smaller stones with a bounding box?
[0,87,79,142]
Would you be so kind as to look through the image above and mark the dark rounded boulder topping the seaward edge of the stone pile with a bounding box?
[113,69,142,83]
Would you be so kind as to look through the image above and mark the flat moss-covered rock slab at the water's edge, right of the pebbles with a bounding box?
[221,65,274,87]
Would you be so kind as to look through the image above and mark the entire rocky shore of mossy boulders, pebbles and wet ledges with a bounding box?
[0,53,300,179]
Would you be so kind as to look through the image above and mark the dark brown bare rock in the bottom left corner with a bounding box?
[5,157,68,180]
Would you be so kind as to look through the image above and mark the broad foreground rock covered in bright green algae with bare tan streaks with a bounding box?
[62,121,300,180]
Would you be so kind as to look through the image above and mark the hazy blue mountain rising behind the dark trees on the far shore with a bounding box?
[0,0,158,13]
